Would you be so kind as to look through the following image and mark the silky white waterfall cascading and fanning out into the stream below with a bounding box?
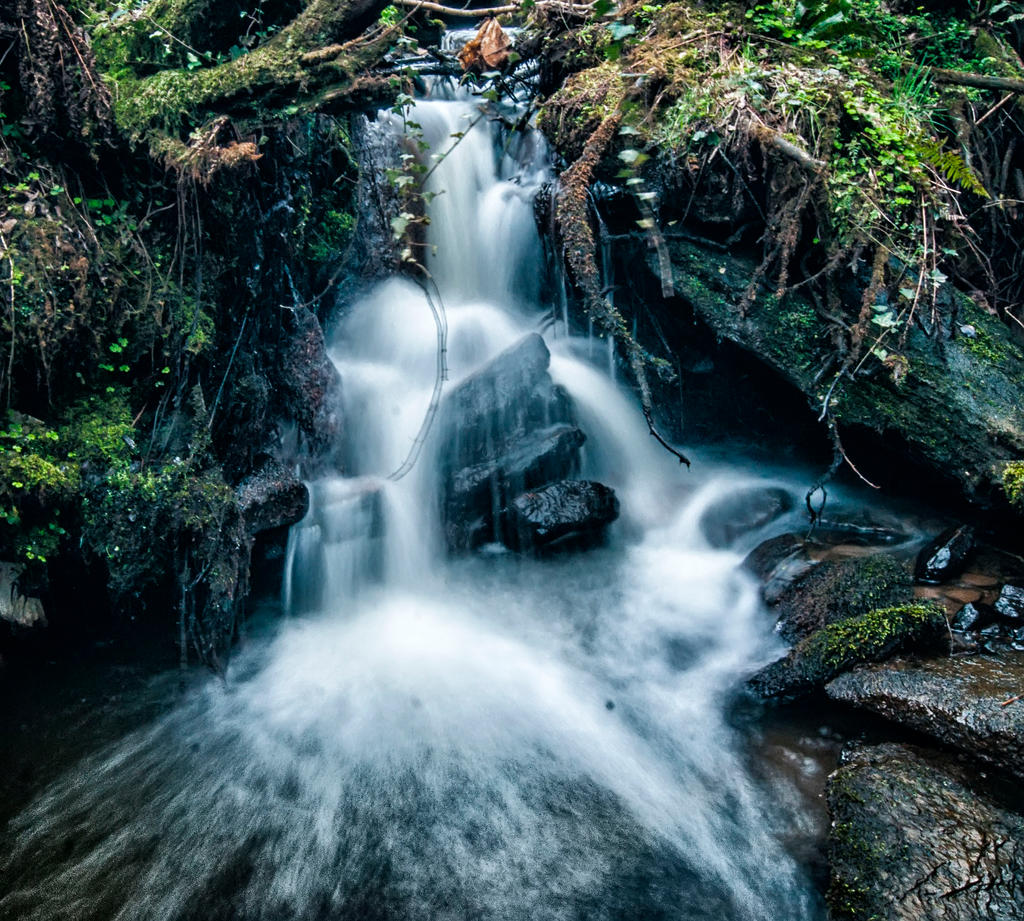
[0,88,847,921]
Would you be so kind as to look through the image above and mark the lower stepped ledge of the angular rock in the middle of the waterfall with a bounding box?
[444,425,585,550]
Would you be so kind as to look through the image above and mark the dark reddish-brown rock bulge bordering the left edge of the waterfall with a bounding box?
[276,306,341,456]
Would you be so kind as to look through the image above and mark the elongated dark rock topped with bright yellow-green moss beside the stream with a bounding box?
[748,603,948,699]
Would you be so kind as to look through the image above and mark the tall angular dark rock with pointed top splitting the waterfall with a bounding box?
[438,333,585,550]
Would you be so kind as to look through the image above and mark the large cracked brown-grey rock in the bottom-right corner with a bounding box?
[828,744,1024,921]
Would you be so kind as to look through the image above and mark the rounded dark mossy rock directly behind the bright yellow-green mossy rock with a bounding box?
[766,553,913,642]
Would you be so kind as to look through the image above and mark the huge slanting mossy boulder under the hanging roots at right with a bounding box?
[648,237,1024,503]
